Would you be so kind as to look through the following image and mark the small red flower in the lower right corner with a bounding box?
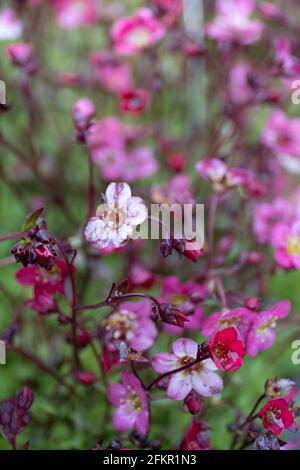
[258,398,295,436]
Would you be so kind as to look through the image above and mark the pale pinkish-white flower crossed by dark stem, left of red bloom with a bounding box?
[152,338,223,400]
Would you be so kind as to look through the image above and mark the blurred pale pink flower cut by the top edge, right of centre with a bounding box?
[206,0,263,45]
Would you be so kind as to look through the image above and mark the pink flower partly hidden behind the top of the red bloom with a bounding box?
[201,307,256,344]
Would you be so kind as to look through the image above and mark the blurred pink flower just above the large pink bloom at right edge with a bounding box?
[253,197,294,243]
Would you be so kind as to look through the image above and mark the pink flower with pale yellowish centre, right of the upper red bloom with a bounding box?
[247,300,291,356]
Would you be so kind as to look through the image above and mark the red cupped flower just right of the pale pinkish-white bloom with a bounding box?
[209,327,245,371]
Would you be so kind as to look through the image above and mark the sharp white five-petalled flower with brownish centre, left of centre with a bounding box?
[84,183,148,249]
